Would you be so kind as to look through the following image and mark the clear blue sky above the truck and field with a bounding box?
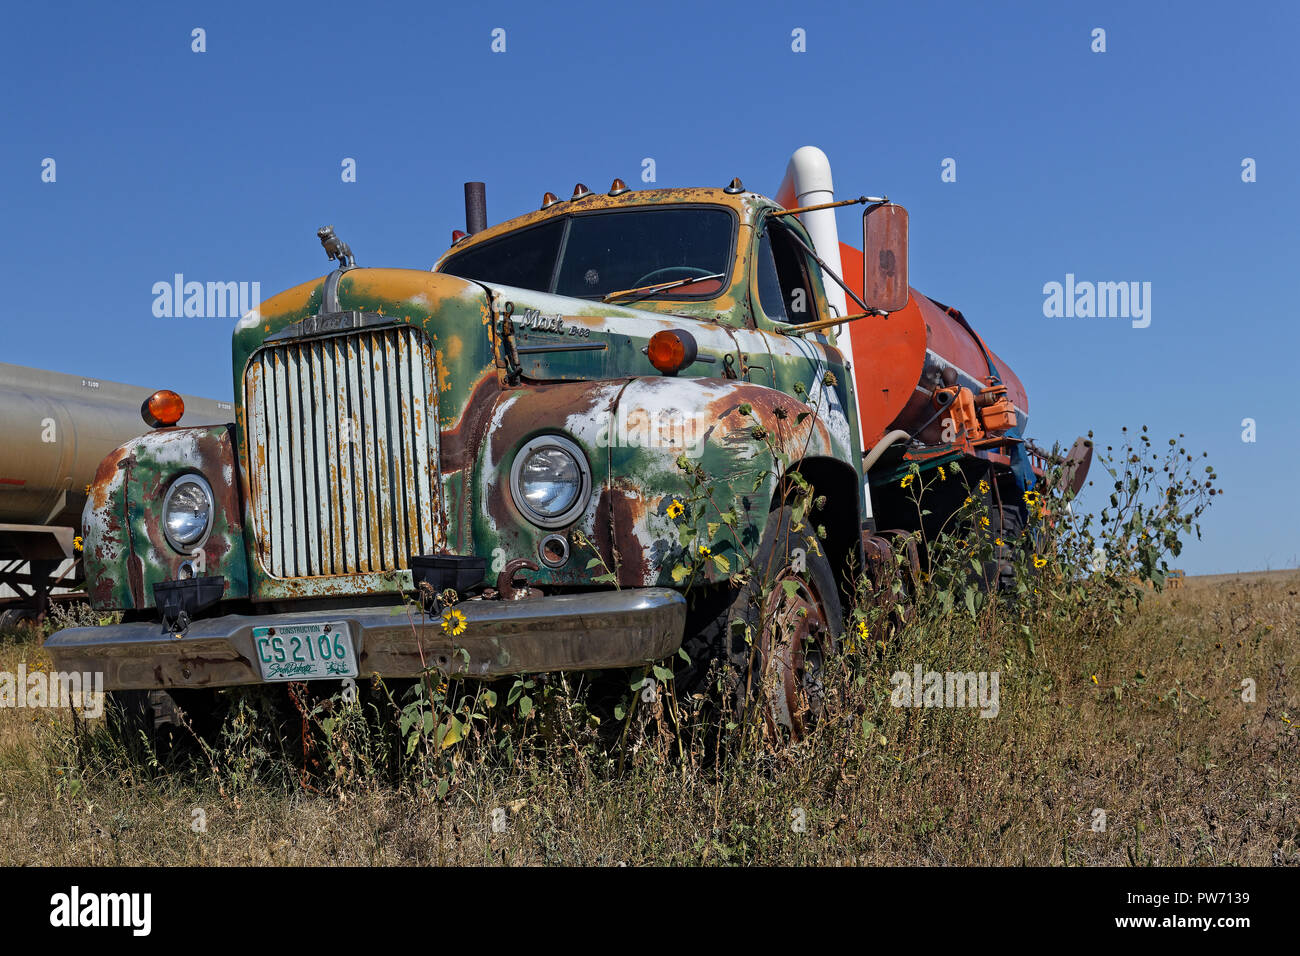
[0,3,1300,574]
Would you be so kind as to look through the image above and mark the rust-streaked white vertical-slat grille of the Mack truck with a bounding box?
[244,328,438,578]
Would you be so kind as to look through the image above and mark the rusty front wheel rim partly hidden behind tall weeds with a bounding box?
[759,568,829,740]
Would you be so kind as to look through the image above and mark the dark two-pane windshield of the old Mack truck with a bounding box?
[442,206,735,299]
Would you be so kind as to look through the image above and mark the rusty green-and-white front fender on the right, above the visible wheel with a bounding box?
[476,376,852,588]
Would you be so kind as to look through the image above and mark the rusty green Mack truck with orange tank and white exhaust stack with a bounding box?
[47,147,1091,731]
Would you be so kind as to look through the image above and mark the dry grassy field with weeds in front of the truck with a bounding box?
[0,571,1300,866]
